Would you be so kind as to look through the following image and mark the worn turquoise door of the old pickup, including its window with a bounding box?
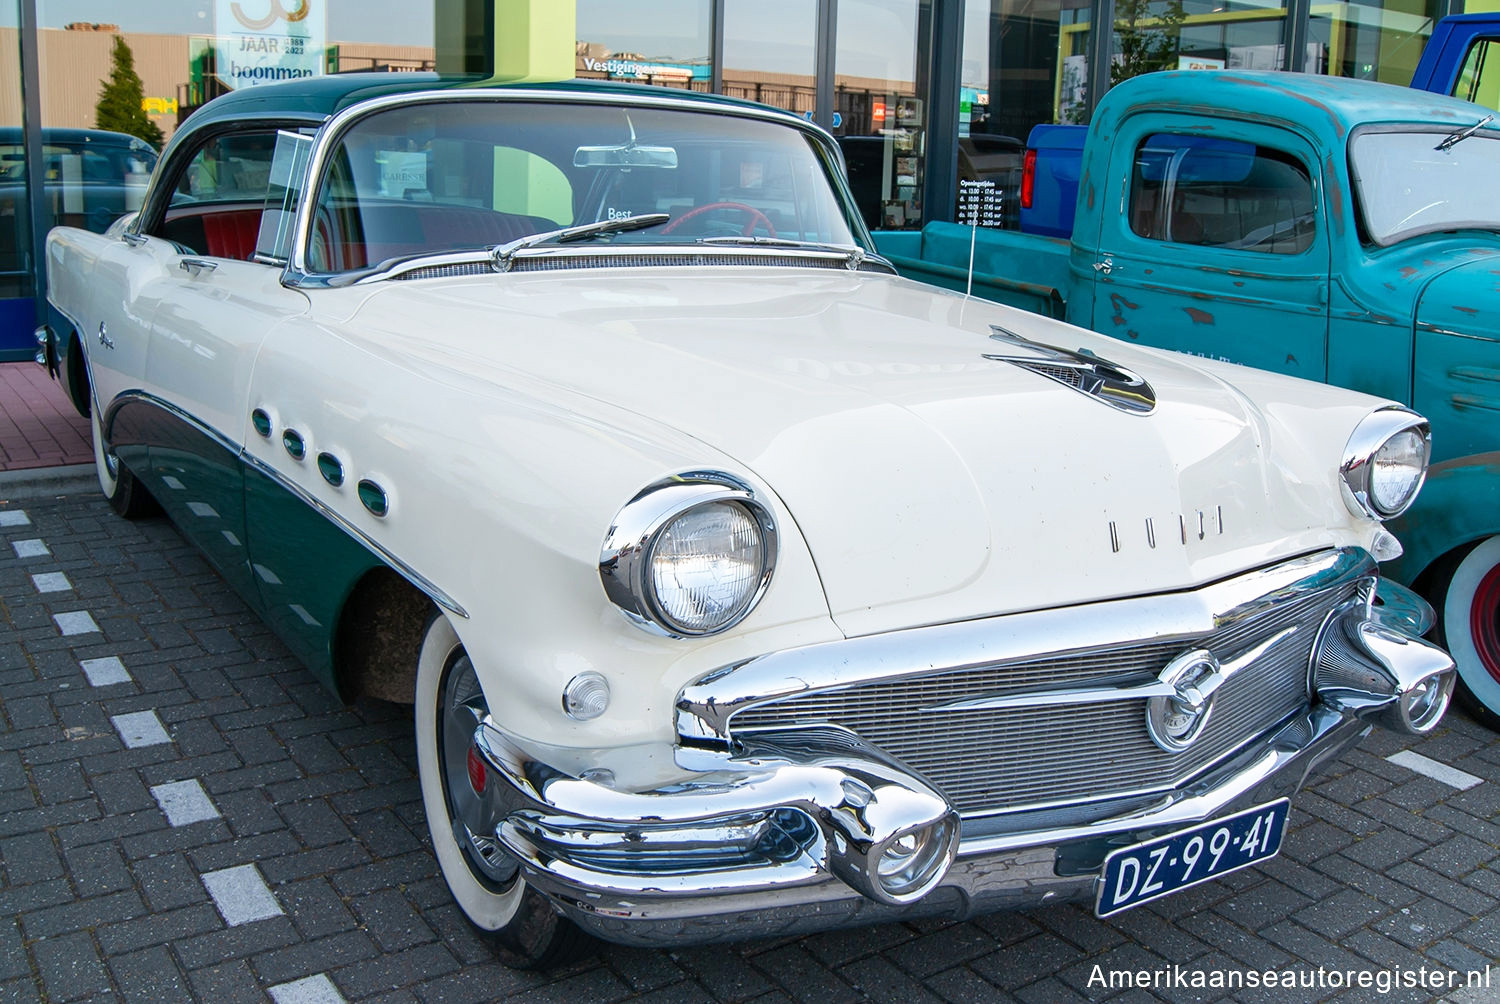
[1092,114,1331,380]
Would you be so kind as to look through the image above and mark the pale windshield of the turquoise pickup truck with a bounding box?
[1349,125,1500,246]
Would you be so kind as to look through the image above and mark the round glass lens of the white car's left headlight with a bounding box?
[650,501,765,635]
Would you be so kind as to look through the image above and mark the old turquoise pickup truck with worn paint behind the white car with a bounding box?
[876,71,1500,728]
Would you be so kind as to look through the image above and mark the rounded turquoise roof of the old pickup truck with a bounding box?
[1094,71,1487,149]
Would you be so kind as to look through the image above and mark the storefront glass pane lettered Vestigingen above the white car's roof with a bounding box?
[575,0,713,92]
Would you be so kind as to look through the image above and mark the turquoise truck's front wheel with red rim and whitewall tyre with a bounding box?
[1439,536,1500,731]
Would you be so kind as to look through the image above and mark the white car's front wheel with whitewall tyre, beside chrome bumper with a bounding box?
[416,614,591,969]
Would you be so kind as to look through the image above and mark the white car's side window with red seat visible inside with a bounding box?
[156,129,276,261]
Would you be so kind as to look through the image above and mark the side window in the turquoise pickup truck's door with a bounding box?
[1130,134,1316,255]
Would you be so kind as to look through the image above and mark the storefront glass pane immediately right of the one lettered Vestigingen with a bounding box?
[723,0,818,116]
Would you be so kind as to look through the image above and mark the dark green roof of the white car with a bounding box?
[183,72,792,131]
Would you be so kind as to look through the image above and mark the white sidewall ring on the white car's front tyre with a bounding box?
[416,615,527,930]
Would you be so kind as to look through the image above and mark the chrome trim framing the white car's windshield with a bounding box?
[282,87,875,288]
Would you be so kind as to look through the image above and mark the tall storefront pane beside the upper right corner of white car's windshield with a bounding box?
[833,0,932,230]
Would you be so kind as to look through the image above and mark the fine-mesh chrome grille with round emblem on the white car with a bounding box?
[729,582,1358,815]
